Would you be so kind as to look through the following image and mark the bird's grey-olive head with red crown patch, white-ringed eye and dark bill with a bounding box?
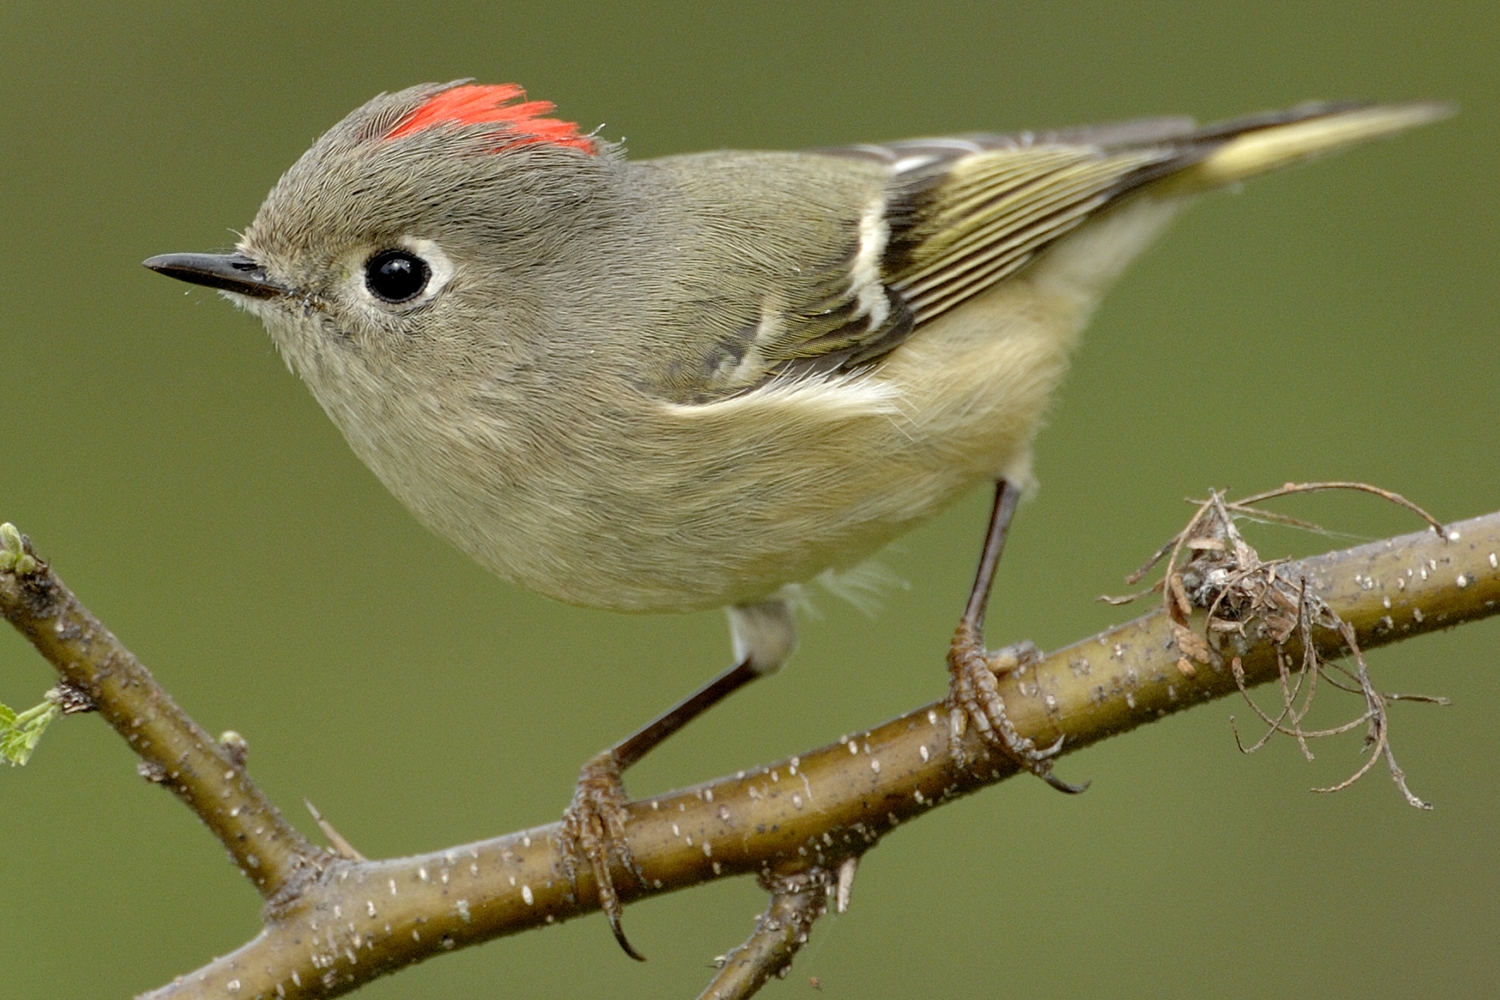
[146,81,620,407]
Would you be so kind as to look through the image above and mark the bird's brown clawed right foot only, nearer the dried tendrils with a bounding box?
[948,624,1089,795]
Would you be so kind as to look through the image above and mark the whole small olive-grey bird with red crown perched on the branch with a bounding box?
[146,82,1448,940]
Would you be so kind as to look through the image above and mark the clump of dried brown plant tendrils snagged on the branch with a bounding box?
[1103,483,1448,810]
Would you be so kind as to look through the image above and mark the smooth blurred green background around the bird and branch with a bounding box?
[0,0,1500,1000]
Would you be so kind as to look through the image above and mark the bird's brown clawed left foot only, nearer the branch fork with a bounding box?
[558,750,645,961]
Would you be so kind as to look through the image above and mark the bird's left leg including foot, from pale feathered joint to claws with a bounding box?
[560,600,797,961]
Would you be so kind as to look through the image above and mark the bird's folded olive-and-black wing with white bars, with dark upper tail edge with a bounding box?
[672,103,1404,400]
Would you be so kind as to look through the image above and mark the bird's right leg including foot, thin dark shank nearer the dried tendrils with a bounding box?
[948,480,1088,793]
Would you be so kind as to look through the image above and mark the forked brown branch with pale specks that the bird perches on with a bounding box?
[0,513,1500,1000]
